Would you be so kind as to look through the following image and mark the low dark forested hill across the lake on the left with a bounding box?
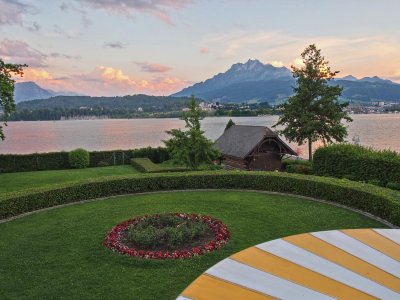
[11,95,194,121]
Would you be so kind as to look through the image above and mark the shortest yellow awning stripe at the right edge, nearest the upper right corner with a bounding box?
[342,229,400,261]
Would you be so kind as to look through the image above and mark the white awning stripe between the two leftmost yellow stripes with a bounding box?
[206,258,334,299]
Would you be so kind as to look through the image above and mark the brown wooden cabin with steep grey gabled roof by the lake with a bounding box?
[215,125,297,171]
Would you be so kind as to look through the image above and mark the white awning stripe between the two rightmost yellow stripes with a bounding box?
[311,231,400,277]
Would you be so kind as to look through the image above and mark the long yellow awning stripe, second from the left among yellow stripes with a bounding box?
[231,247,376,299]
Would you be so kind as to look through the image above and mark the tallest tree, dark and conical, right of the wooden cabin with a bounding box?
[273,44,352,161]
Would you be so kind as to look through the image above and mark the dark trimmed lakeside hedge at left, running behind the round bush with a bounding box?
[0,147,169,172]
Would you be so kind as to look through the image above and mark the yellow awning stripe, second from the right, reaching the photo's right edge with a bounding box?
[283,234,400,292]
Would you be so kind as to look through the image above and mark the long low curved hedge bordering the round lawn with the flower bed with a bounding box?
[0,171,400,225]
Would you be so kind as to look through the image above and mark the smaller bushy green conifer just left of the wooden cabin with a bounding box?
[163,96,219,170]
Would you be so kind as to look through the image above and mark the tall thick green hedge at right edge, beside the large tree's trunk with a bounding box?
[313,144,400,186]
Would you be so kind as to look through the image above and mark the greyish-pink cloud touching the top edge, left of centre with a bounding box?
[77,0,193,25]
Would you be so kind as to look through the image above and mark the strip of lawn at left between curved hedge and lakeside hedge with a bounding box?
[0,166,138,193]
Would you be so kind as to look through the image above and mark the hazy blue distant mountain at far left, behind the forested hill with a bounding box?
[14,81,79,103]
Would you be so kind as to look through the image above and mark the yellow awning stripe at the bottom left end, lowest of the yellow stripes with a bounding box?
[181,274,276,300]
